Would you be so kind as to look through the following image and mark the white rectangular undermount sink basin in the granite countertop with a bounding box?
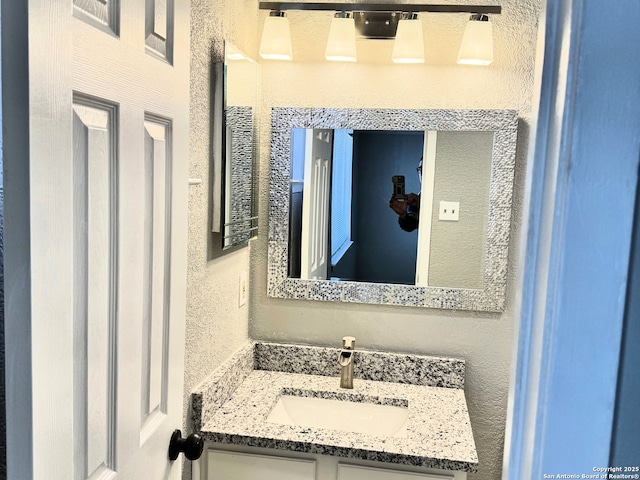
[267,395,408,437]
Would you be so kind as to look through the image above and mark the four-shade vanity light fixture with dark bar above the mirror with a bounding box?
[259,2,502,65]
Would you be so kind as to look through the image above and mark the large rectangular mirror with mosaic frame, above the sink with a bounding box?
[268,108,517,312]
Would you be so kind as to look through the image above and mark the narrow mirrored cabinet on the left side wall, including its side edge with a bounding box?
[212,42,259,250]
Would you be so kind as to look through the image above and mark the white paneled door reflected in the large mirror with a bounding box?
[300,129,333,279]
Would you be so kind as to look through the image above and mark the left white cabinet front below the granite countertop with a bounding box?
[207,450,316,480]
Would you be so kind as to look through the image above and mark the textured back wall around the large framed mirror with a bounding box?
[249,0,540,480]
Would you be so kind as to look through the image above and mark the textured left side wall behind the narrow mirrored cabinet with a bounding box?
[184,0,258,479]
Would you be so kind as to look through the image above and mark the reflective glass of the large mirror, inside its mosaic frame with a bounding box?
[288,128,494,289]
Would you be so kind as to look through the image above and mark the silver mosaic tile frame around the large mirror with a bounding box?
[267,108,518,312]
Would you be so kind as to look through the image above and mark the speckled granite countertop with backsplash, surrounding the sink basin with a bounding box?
[192,343,478,472]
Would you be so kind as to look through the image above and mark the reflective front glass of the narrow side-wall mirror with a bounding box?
[221,42,259,249]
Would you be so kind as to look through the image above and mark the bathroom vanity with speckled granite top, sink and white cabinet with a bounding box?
[191,342,478,480]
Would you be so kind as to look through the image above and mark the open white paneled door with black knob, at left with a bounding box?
[2,0,189,480]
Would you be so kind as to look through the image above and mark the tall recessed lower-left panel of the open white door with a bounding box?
[73,95,117,479]
